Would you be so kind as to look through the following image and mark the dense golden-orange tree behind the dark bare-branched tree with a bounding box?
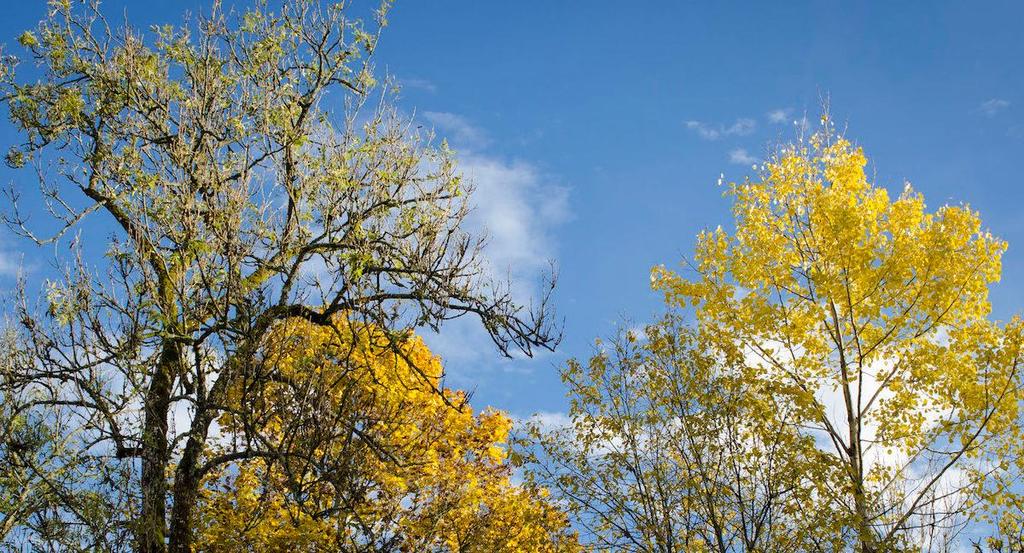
[198,320,579,553]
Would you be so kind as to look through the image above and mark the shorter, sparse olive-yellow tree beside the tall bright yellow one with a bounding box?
[518,311,843,553]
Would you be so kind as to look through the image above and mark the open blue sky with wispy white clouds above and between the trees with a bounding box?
[0,0,1024,416]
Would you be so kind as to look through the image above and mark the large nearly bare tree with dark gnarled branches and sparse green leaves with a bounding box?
[0,0,558,552]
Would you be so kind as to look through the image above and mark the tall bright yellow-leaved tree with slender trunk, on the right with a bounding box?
[652,117,1022,552]
